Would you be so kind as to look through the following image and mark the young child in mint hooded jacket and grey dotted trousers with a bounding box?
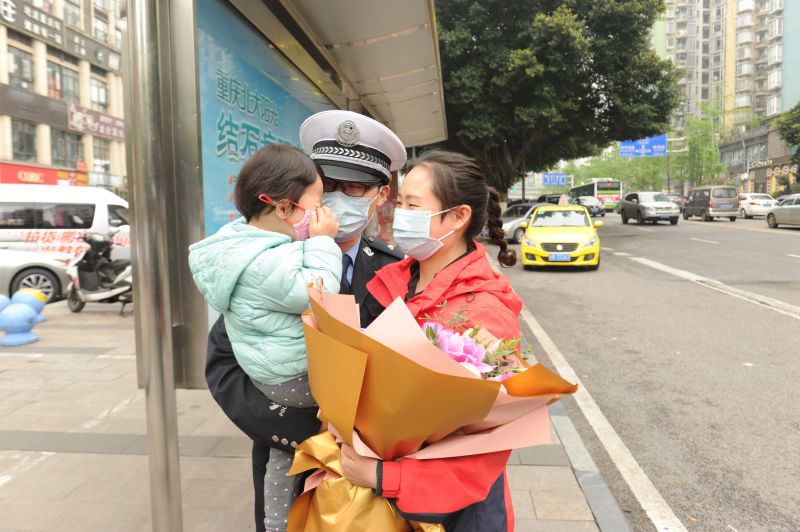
[189,144,342,531]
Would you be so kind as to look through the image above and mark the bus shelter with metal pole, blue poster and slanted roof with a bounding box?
[124,0,447,531]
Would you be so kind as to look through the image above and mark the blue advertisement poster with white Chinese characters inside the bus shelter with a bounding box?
[197,0,335,235]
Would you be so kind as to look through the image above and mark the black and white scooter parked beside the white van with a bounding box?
[67,233,133,316]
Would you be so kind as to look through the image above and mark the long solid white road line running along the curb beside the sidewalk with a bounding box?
[520,305,686,532]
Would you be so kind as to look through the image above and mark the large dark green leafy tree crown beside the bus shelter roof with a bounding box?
[436,0,678,191]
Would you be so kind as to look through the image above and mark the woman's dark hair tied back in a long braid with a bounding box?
[409,150,517,266]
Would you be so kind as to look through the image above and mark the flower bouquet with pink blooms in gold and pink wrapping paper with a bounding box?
[289,288,577,531]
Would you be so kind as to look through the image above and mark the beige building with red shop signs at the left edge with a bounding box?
[0,0,127,194]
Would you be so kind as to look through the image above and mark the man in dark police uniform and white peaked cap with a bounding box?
[206,111,406,531]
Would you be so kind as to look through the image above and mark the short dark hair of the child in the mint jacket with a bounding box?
[235,144,322,222]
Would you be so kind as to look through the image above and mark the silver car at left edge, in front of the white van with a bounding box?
[0,249,72,303]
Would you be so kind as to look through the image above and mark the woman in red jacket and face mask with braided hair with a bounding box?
[342,150,522,532]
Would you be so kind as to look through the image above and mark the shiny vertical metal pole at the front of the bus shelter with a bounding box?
[126,0,183,532]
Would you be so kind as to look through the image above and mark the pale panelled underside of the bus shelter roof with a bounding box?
[281,0,447,147]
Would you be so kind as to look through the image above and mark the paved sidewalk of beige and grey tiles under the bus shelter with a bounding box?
[0,302,618,532]
